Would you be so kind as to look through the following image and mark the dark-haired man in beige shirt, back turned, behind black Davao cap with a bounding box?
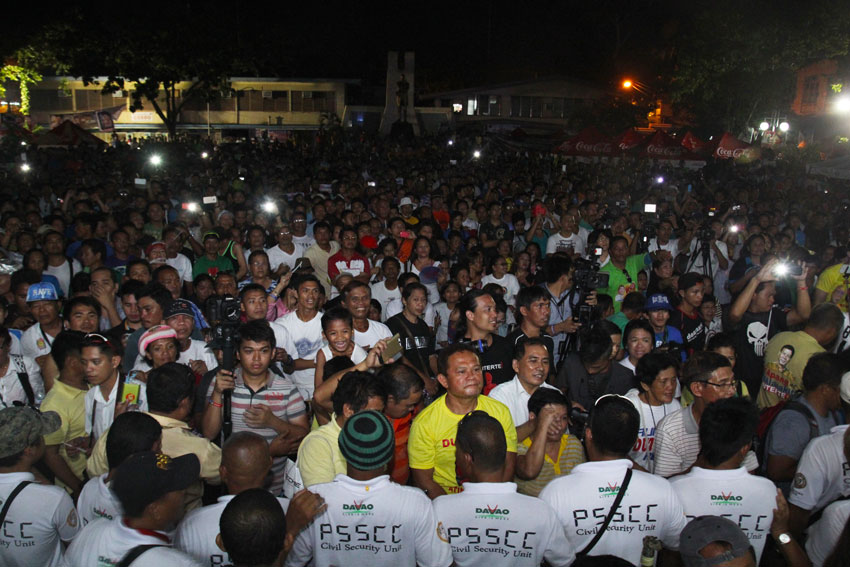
[86,362,221,512]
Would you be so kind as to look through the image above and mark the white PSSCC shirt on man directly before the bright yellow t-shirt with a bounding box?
[434,482,575,567]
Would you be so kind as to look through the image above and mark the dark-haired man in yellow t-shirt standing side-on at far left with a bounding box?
[41,331,88,501]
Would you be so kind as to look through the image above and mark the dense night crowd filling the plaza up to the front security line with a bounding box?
[0,129,850,567]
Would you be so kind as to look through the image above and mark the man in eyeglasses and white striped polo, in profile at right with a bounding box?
[655,351,758,477]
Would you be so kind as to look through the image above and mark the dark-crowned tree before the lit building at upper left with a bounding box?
[19,6,251,138]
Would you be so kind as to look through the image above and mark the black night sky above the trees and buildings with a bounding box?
[0,0,686,92]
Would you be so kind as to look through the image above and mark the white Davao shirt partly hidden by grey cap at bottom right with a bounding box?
[670,467,776,563]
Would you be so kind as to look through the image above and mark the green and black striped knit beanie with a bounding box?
[339,410,395,471]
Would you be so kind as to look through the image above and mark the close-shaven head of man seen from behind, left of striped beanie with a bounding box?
[220,431,272,494]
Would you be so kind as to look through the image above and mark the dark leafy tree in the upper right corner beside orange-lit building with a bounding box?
[671,0,850,133]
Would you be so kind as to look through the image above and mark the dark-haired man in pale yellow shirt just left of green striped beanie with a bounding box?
[295,372,387,488]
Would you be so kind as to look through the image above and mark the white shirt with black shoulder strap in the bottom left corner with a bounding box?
[0,473,80,567]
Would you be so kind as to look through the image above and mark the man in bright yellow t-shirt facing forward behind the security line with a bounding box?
[407,343,517,499]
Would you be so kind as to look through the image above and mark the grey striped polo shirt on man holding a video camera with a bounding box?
[207,368,307,494]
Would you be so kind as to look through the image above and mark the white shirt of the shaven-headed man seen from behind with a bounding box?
[174,494,289,567]
